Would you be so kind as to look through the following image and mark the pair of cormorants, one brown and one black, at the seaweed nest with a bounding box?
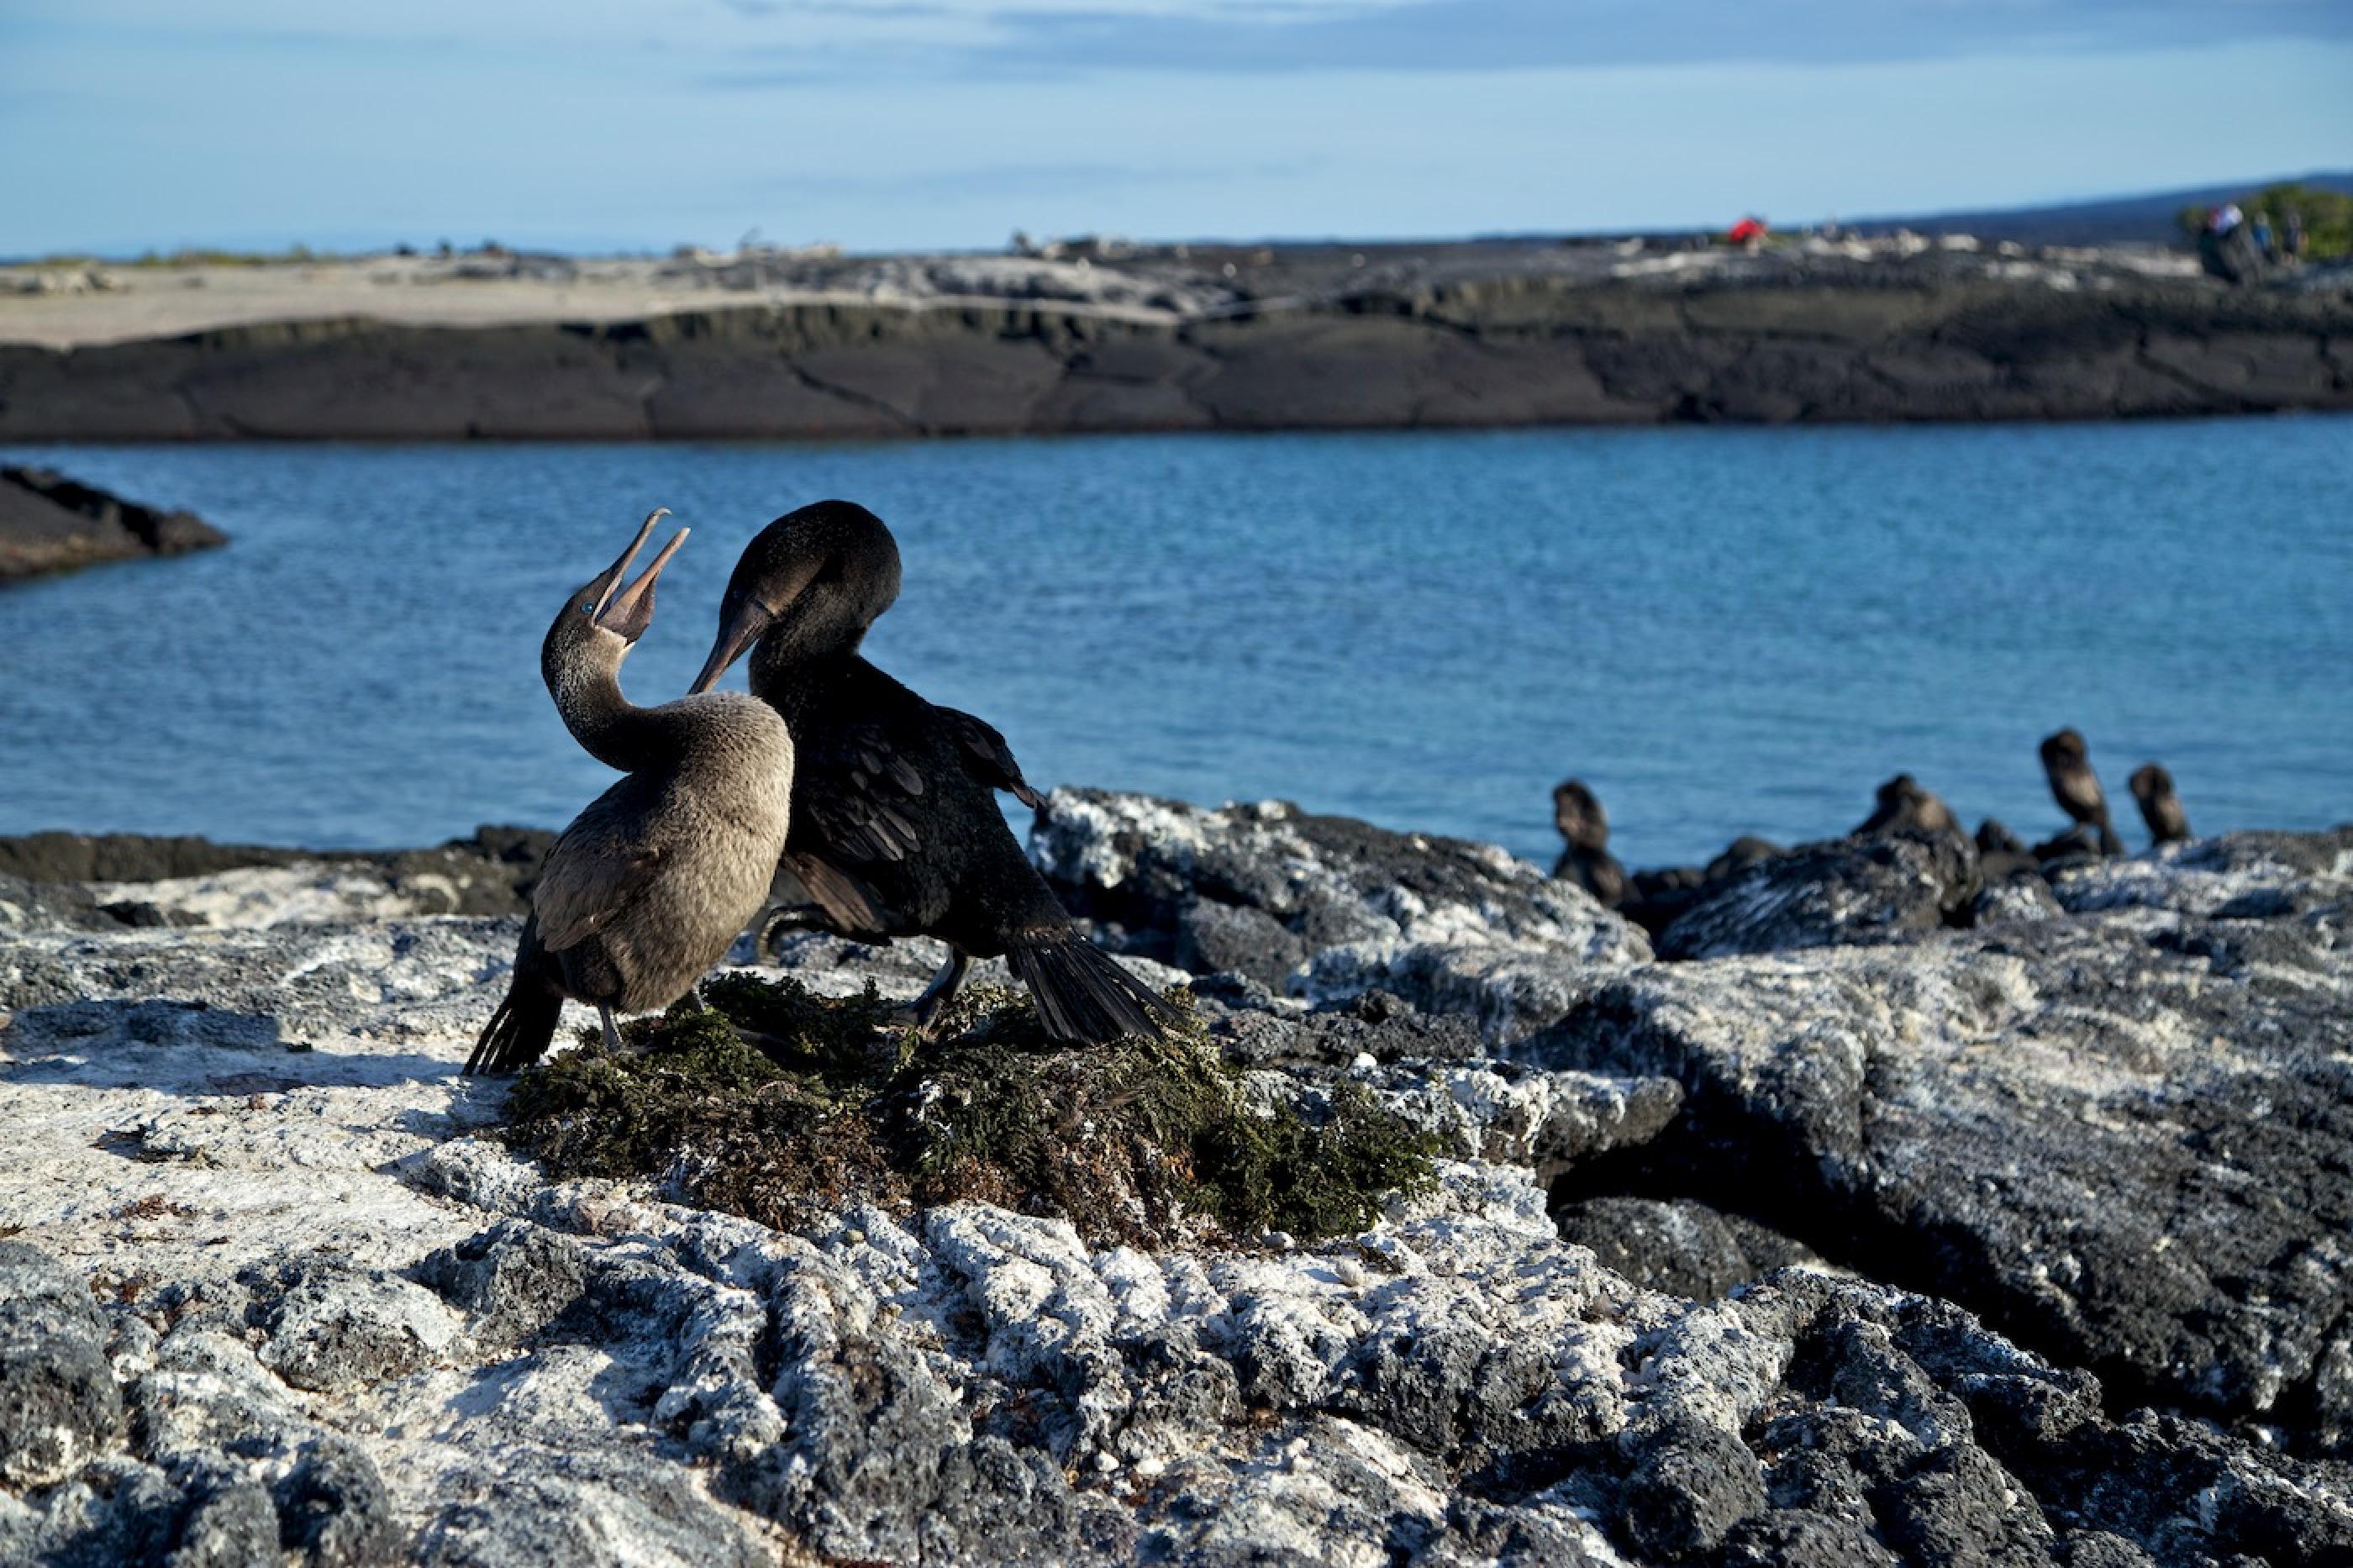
[466,502,1167,1071]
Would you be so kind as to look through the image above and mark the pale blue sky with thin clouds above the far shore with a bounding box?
[0,0,2353,255]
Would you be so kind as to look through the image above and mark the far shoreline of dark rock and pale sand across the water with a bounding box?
[0,235,2353,440]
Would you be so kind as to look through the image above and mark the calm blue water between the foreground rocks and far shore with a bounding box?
[0,417,2353,864]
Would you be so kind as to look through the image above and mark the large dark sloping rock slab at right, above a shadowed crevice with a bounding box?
[1523,834,2353,1453]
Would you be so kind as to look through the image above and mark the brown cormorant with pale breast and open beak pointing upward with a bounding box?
[466,511,793,1074]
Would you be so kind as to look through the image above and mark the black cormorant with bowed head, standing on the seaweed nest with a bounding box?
[692,502,1167,1043]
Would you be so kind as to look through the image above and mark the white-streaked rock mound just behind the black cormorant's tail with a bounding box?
[1030,789,1650,1040]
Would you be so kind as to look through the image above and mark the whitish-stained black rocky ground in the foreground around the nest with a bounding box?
[0,791,2353,1565]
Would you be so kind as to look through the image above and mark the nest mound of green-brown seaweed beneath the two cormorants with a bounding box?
[503,975,1435,1245]
